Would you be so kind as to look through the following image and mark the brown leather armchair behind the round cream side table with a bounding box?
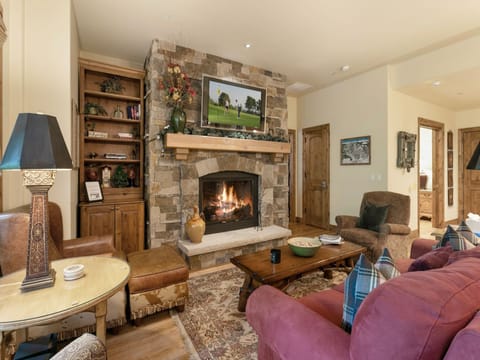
[0,202,127,340]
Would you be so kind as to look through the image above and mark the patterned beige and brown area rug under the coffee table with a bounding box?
[174,268,346,360]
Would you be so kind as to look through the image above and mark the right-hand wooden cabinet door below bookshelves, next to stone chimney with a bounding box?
[115,202,145,254]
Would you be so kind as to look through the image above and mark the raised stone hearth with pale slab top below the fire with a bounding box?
[178,225,292,270]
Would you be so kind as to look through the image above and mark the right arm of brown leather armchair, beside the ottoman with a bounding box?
[63,235,116,257]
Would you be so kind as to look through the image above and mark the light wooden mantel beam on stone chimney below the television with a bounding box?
[165,133,290,161]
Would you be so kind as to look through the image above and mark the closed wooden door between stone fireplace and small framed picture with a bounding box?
[303,124,330,229]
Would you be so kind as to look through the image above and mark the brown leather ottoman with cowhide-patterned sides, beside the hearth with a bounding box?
[127,245,188,320]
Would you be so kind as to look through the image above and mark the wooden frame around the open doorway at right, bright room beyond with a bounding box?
[417,117,445,229]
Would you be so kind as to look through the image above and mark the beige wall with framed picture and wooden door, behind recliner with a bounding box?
[297,67,388,224]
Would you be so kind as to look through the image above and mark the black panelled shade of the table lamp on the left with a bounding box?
[0,113,72,170]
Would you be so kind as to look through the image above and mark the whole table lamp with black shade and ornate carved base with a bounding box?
[0,113,72,291]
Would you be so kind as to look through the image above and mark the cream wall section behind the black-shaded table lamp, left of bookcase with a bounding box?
[2,0,78,238]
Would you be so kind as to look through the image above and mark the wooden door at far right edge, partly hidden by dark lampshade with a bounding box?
[459,128,480,220]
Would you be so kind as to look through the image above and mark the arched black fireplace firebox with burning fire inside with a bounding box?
[199,171,258,234]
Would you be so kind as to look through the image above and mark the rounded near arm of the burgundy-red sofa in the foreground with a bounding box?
[246,285,350,359]
